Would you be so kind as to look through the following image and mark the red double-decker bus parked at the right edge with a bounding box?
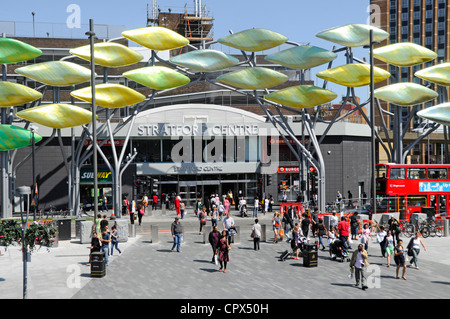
[376,164,450,220]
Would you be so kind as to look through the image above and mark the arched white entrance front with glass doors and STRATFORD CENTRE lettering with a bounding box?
[127,104,277,207]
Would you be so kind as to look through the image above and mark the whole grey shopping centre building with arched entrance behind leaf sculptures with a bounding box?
[0,11,371,215]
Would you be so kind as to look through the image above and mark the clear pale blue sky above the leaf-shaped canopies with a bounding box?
[0,0,369,101]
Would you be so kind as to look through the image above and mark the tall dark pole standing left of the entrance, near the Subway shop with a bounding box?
[86,19,98,216]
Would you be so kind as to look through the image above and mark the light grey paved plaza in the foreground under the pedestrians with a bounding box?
[0,211,450,300]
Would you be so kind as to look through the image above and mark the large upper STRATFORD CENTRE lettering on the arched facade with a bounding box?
[137,123,259,136]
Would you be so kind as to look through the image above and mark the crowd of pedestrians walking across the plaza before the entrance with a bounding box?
[110,191,426,290]
